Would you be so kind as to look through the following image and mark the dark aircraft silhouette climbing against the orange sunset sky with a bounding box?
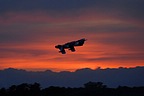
[55,38,86,54]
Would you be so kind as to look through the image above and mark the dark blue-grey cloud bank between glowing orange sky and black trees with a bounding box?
[0,67,144,88]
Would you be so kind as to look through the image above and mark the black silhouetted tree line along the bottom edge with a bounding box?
[0,81,144,96]
